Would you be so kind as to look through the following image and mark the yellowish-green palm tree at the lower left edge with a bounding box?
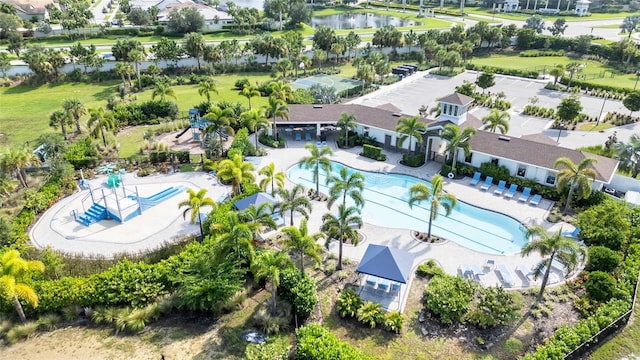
[0,250,44,323]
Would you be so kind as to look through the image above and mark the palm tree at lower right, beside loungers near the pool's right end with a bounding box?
[522,225,585,302]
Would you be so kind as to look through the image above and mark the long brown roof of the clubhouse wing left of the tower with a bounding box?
[284,104,433,131]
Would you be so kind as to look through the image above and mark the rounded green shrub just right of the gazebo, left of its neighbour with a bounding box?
[424,275,473,324]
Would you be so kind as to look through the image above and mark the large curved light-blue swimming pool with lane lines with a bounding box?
[287,162,527,254]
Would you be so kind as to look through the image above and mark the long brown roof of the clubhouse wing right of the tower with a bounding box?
[470,131,618,183]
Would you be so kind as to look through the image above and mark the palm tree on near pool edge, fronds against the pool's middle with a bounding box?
[409,174,458,239]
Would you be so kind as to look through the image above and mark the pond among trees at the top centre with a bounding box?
[311,13,422,30]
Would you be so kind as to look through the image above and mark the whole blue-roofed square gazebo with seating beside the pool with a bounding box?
[356,244,415,311]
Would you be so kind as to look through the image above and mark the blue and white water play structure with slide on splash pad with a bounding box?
[72,169,186,226]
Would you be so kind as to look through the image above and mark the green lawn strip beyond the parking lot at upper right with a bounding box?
[471,54,636,88]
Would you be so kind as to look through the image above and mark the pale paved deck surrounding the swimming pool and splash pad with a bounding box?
[30,141,573,308]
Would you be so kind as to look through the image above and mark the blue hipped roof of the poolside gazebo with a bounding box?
[356,244,415,284]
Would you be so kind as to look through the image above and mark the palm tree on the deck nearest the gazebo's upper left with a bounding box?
[320,204,362,270]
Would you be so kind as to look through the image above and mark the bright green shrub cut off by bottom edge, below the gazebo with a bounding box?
[296,324,372,360]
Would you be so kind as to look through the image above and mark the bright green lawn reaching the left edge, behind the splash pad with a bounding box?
[0,81,119,151]
